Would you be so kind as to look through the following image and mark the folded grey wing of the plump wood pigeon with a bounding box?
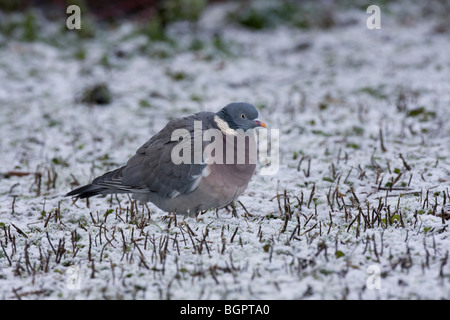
[93,112,213,198]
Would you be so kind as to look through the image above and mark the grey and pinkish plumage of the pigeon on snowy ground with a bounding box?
[67,103,265,213]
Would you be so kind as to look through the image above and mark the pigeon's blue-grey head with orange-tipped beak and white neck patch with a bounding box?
[215,102,266,133]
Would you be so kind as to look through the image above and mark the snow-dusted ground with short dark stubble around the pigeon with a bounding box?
[0,0,450,299]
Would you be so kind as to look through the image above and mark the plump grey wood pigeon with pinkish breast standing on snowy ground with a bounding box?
[66,102,266,214]
